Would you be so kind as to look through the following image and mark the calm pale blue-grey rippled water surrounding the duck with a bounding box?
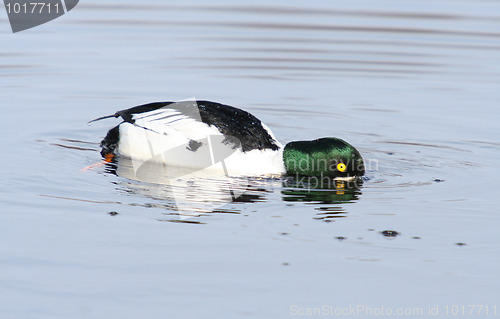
[0,0,500,319]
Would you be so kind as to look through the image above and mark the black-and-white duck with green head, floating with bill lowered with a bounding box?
[89,101,365,179]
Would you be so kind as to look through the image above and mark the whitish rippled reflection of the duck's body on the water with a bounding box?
[102,157,264,219]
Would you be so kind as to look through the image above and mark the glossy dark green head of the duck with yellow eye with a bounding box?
[283,137,365,178]
